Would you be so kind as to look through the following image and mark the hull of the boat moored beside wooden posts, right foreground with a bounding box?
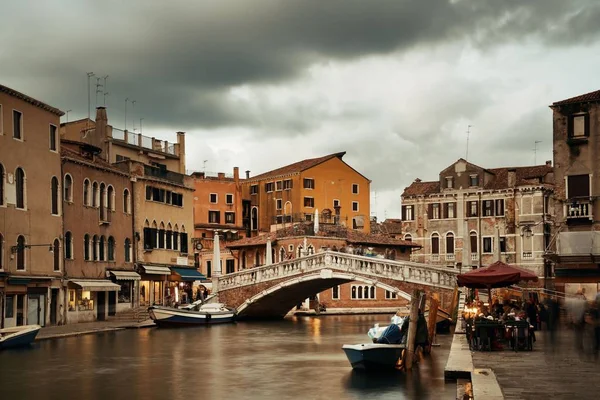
[342,343,406,370]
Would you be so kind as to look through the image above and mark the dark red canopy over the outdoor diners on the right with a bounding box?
[457,261,538,289]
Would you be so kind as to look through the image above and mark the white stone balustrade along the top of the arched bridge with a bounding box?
[219,250,458,290]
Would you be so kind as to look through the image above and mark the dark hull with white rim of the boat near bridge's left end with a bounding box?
[148,307,235,327]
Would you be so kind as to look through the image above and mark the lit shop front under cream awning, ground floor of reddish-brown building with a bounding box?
[66,279,121,323]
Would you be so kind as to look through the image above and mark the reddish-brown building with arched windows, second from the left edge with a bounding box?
[61,140,140,323]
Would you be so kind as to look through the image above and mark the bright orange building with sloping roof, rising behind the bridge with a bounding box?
[242,152,371,235]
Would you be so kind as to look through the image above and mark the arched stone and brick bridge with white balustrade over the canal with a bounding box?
[217,251,458,318]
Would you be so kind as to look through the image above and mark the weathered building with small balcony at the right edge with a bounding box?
[547,91,600,299]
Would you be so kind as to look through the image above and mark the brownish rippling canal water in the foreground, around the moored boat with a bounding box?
[0,315,456,400]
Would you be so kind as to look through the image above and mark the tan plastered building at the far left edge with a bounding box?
[0,85,64,327]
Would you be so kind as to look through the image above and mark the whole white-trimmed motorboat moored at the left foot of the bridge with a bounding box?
[148,295,236,327]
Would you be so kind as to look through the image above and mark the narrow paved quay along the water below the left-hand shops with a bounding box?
[36,320,155,340]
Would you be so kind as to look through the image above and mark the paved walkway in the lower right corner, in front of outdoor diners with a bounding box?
[472,330,600,400]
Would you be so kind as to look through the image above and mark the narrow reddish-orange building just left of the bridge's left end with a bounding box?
[192,167,250,278]
